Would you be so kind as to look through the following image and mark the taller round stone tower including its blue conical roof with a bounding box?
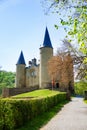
[39,27,53,88]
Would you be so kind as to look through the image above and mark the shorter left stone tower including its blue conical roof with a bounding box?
[16,51,26,88]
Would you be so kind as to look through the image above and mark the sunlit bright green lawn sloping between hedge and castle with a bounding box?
[13,89,60,98]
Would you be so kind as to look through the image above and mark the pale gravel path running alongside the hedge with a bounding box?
[40,98,87,130]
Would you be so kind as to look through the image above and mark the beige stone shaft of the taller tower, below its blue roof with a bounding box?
[39,47,53,88]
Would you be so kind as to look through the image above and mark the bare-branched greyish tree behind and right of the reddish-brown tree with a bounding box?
[57,39,87,80]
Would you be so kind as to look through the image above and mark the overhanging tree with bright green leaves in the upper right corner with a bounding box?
[41,0,87,79]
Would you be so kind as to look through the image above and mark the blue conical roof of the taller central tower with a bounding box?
[43,27,53,48]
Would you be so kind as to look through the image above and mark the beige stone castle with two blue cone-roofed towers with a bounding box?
[16,27,74,92]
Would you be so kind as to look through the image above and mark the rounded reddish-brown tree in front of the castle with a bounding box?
[48,51,74,90]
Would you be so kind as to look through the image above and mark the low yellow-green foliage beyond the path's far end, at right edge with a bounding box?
[75,81,87,96]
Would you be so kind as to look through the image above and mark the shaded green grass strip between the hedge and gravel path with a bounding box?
[17,101,68,130]
